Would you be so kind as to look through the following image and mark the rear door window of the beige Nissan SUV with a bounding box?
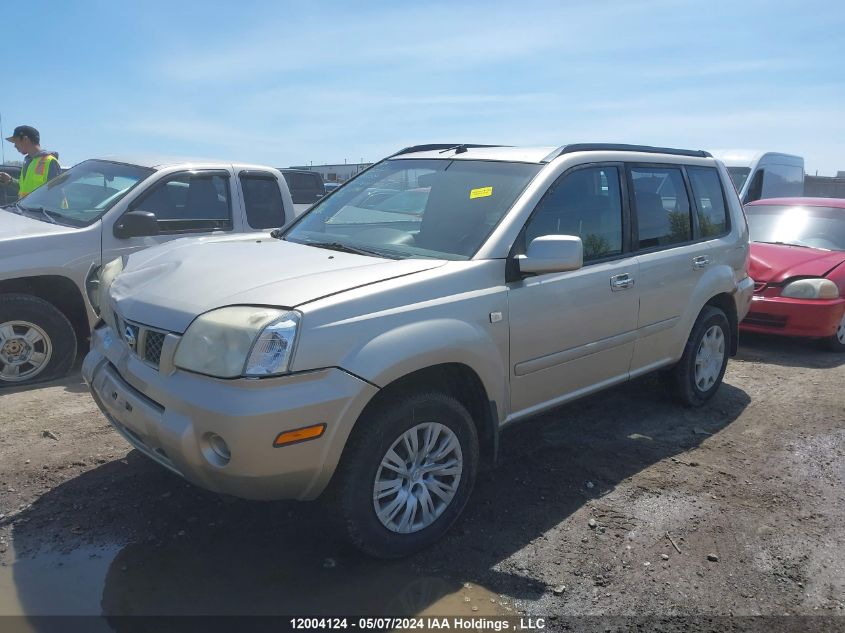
[631,167,692,249]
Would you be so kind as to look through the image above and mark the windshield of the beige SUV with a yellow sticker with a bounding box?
[285,159,541,260]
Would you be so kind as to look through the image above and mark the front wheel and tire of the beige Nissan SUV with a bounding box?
[336,393,478,558]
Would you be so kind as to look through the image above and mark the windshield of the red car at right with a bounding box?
[745,204,845,251]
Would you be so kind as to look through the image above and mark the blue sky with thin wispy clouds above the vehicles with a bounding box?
[0,0,845,175]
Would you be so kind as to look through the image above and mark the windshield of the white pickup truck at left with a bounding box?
[18,160,153,226]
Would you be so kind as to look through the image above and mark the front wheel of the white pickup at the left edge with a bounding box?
[0,294,76,388]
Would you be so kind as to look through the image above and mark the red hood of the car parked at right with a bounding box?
[748,242,845,283]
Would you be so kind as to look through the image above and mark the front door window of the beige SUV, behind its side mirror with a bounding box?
[525,167,622,262]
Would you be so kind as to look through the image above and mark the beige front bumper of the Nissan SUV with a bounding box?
[82,326,378,499]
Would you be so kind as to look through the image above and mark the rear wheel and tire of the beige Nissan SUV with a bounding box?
[667,306,731,407]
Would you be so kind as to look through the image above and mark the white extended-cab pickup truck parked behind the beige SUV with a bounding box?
[0,159,296,388]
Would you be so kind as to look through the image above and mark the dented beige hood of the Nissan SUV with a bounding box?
[110,234,445,332]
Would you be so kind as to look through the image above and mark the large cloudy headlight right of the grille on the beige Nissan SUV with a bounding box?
[174,306,299,378]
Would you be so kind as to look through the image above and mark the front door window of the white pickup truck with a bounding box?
[133,172,232,233]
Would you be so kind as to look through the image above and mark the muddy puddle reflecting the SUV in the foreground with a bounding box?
[0,539,514,616]
